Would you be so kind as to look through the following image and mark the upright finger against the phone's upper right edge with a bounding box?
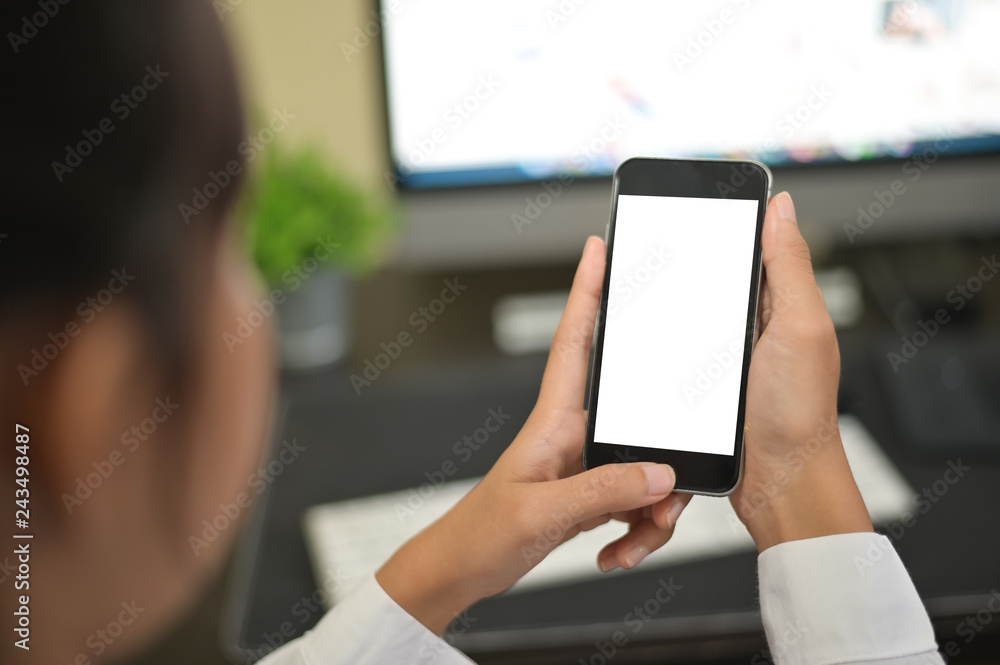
[762,192,826,318]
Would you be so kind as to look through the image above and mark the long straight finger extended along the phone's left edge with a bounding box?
[538,236,605,409]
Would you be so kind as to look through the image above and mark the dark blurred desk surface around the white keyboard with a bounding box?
[224,338,1000,663]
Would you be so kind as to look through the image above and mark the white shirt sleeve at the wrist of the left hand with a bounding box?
[259,574,472,665]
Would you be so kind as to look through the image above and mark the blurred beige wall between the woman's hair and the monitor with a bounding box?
[226,0,386,191]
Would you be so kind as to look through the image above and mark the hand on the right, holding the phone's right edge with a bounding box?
[730,193,872,551]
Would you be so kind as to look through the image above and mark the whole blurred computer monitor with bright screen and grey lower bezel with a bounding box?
[381,0,1000,270]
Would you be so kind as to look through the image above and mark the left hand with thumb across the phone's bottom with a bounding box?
[377,238,690,634]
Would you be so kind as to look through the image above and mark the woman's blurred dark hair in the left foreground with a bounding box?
[0,0,244,394]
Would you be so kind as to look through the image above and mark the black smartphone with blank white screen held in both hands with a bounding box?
[583,158,771,496]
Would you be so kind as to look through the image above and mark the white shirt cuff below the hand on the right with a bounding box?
[758,533,944,665]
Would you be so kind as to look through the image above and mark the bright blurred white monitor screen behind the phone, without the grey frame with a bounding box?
[381,0,1000,189]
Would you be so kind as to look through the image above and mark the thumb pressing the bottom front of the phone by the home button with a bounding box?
[542,462,676,523]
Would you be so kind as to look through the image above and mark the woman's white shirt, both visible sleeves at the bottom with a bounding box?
[260,533,944,665]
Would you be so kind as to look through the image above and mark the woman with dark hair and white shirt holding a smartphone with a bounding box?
[0,0,940,665]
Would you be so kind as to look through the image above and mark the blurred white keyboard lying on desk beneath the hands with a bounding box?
[303,415,915,606]
